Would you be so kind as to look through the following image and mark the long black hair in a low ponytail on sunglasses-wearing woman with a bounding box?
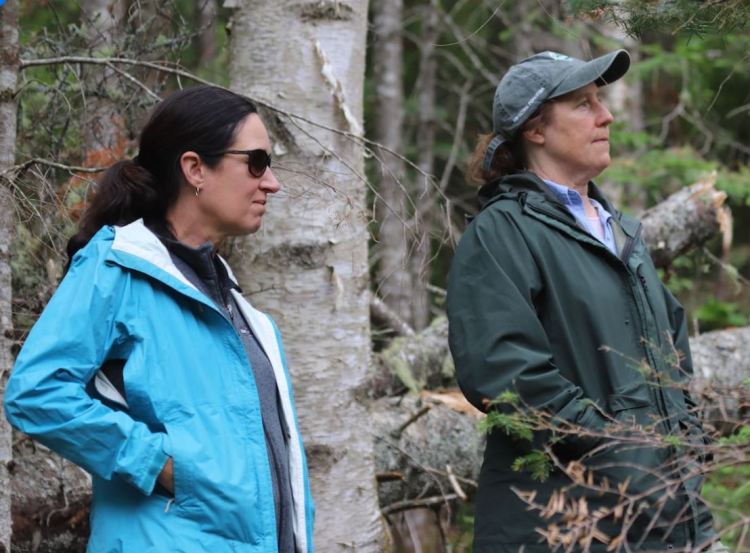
[67,86,257,262]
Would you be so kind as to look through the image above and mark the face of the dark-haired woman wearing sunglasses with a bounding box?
[195,113,279,239]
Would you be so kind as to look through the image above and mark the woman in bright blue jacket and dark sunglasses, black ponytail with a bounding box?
[5,87,312,553]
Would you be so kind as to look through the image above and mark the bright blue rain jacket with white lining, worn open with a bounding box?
[5,221,313,553]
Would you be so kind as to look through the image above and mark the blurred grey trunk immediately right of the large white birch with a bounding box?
[371,0,412,324]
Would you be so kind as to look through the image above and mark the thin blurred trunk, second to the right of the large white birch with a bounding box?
[411,0,439,330]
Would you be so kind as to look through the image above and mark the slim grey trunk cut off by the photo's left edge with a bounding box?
[0,0,18,551]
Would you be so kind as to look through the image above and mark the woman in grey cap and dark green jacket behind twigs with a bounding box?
[448,50,715,553]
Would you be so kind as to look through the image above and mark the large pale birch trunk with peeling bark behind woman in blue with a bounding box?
[225,0,385,552]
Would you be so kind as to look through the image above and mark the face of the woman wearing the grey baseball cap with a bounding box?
[525,83,613,187]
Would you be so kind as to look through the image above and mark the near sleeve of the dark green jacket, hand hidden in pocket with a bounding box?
[448,209,606,453]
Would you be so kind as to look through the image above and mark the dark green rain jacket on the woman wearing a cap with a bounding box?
[448,173,714,553]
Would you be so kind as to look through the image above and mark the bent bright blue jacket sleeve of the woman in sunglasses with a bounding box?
[5,239,167,494]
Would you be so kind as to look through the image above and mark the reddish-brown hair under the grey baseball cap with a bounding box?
[468,100,554,184]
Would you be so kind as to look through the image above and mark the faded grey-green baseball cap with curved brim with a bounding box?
[482,50,630,171]
